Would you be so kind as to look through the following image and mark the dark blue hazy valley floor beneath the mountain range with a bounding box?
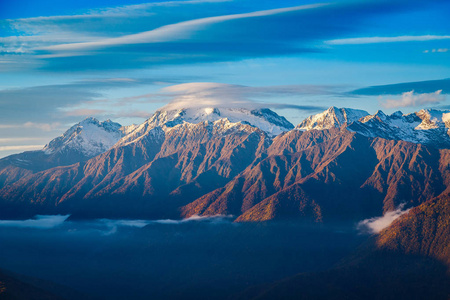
[0,216,367,299]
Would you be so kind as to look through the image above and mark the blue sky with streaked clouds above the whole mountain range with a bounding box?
[0,0,450,157]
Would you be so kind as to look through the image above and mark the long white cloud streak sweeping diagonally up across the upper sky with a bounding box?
[42,3,327,51]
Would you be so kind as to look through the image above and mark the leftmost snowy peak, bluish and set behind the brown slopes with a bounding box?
[43,117,128,157]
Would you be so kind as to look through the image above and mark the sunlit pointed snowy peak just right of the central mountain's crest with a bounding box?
[296,106,369,130]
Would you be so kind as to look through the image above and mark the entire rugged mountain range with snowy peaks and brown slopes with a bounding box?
[0,107,450,222]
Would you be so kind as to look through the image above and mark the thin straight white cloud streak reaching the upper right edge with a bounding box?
[325,35,450,45]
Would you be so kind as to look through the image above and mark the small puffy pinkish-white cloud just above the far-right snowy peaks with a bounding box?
[381,90,445,108]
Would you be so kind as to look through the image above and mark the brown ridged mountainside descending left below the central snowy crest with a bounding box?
[0,122,269,217]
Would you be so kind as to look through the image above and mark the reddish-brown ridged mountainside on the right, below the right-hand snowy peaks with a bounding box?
[182,129,448,222]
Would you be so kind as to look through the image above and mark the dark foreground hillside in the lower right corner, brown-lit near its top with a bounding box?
[234,195,450,300]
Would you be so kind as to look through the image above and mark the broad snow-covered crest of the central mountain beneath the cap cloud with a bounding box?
[117,107,294,145]
